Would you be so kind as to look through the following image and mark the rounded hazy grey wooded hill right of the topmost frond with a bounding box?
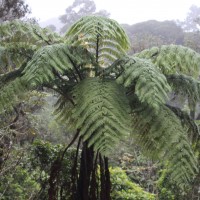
[122,20,184,53]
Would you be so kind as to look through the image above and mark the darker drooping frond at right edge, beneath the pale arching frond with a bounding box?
[166,74,200,108]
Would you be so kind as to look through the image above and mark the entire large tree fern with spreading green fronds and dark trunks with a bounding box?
[0,16,200,200]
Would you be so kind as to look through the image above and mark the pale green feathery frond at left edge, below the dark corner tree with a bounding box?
[0,20,61,73]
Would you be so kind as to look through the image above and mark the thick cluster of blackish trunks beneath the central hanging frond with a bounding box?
[77,143,111,200]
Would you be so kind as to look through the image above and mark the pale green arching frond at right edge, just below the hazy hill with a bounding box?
[135,45,200,77]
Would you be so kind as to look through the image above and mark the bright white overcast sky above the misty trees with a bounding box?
[25,0,200,24]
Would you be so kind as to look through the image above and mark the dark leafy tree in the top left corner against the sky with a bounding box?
[0,0,30,22]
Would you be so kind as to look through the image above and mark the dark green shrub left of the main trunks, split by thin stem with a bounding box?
[30,140,76,199]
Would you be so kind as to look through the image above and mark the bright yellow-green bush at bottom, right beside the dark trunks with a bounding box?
[109,167,156,200]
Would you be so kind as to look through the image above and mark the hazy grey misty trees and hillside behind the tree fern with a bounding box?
[38,0,200,52]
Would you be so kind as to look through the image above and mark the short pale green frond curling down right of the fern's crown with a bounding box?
[117,57,171,110]
